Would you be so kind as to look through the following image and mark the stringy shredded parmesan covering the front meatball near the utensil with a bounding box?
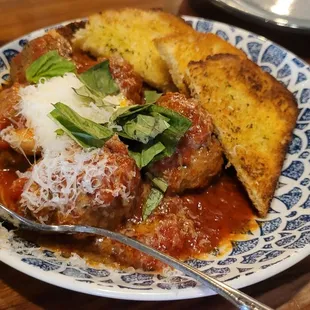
[19,148,133,222]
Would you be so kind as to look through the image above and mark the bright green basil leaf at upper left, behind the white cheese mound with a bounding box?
[26,51,76,83]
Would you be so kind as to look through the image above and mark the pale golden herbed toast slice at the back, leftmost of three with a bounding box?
[73,8,194,90]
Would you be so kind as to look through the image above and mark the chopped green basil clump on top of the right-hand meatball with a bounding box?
[110,104,191,168]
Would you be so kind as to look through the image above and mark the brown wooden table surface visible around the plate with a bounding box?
[0,0,310,310]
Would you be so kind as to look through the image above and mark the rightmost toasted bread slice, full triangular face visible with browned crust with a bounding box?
[185,54,298,216]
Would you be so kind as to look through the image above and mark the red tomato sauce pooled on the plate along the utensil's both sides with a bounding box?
[0,171,255,271]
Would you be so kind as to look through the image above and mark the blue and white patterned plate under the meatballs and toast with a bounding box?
[0,16,310,300]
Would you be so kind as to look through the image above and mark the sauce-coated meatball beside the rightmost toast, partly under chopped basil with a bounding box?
[150,93,223,193]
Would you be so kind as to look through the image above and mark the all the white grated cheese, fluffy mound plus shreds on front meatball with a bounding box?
[7,73,133,222]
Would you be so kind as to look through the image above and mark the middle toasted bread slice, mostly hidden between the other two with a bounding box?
[154,31,246,95]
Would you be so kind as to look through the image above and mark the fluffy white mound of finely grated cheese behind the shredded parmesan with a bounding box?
[19,73,122,151]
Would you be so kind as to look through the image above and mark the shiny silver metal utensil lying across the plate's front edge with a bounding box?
[0,204,272,310]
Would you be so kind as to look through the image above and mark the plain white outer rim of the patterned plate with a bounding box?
[0,15,310,301]
